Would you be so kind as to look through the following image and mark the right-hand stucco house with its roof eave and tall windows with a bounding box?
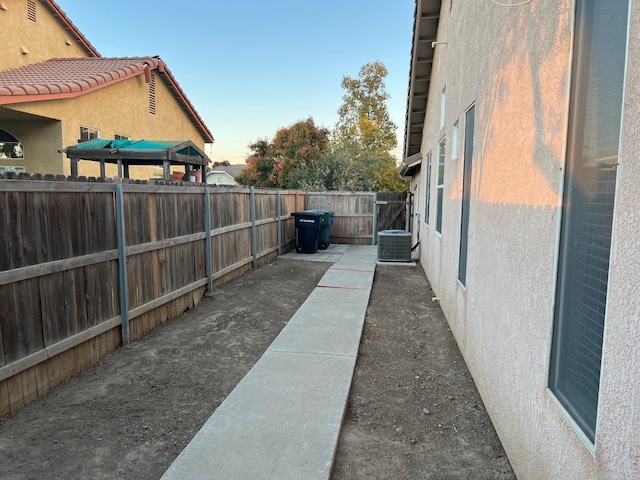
[400,0,640,480]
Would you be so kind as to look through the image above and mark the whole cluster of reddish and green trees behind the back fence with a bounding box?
[236,62,408,191]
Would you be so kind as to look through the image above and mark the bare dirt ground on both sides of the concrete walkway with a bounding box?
[0,259,515,480]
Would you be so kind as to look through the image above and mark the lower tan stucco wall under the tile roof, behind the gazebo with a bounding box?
[7,73,204,179]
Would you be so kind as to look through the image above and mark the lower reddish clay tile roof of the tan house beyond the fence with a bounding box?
[0,57,213,143]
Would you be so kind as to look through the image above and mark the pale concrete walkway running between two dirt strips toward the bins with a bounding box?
[162,245,377,480]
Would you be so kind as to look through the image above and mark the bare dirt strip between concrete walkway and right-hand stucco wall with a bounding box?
[332,266,515,480]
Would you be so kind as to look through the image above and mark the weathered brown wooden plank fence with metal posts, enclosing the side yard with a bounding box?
[0,175,402,417]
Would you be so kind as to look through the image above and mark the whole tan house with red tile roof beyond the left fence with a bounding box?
[0,0,213,178]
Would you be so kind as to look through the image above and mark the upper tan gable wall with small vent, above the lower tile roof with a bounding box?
[0,0,89,70]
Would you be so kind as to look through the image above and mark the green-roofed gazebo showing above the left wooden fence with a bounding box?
[62,139,209,180]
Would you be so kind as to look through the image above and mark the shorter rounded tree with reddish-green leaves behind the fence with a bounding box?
[236,117,329,188]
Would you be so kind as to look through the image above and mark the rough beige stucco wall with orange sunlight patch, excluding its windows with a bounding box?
[414,0,640,480]
